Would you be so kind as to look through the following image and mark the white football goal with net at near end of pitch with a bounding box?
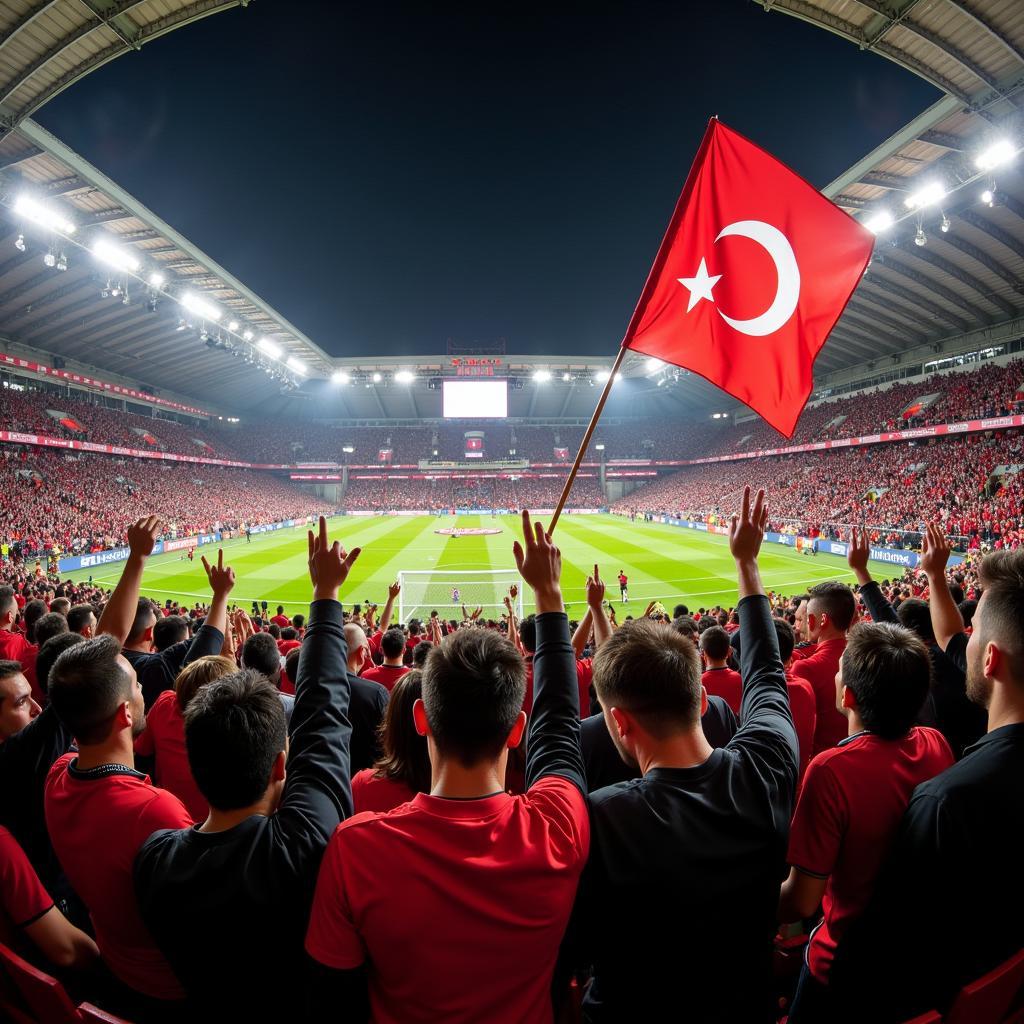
[398,569,523,623]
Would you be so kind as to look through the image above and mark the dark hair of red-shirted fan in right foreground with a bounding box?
[843,623,932,739]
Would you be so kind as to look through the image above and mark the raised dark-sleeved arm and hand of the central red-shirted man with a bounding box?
[512,511,587,797]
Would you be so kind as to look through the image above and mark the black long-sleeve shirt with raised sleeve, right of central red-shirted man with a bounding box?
[567,595,800,1024]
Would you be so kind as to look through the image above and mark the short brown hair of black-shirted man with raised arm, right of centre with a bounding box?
[594,618,700,738]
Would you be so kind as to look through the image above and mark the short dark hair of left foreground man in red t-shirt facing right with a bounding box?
[48,633,132,745]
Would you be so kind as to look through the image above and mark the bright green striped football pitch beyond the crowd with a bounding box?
[64,515,852,618]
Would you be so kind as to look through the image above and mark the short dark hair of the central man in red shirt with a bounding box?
[423,630,526,767]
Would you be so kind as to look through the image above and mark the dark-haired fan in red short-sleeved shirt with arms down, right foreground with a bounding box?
[779,623,953,1024]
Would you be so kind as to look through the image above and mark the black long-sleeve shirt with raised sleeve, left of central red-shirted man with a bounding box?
[135,601,352,1021]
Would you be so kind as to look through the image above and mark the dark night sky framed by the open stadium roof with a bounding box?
[37,0,939,355]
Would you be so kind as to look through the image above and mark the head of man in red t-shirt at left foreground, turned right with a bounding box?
[48,634,145,746]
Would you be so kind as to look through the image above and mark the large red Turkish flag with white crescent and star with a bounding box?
[623,119,874,437]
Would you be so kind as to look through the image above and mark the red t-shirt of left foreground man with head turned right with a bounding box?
[45,754,193,999]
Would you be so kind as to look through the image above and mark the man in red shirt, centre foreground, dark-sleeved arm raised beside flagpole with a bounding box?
[306,512,590,1024]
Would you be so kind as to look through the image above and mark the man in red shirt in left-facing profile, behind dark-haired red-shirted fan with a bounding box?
[793,581,857,754]
